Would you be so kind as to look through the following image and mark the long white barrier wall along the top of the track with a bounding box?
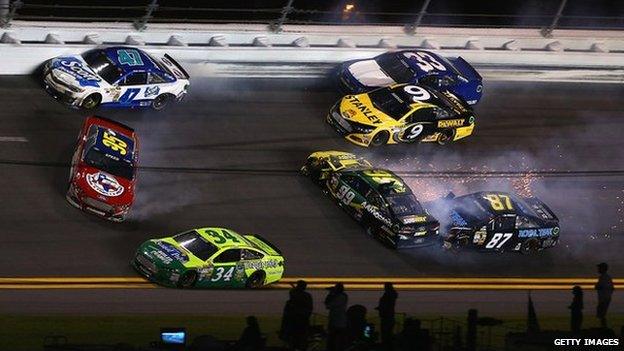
[0,21,624,82]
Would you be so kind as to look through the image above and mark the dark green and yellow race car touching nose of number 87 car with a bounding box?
[301,151,440,249]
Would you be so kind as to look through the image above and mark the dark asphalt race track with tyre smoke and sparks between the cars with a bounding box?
[0,77,624,284]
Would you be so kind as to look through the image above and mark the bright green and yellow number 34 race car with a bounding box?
[131,228,284,288]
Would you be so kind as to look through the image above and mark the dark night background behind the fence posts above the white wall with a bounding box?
[8,0,624,29]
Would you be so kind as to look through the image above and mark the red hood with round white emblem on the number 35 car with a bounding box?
[74,164,134,206]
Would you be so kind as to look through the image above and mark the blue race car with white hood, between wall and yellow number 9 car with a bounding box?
[336,50,483,105]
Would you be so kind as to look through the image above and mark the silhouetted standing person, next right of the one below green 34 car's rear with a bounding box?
[325,283,348,351]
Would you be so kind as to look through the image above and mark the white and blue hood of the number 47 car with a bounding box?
[50,55,104,88]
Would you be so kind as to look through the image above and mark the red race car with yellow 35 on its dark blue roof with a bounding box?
[66,116,139,222]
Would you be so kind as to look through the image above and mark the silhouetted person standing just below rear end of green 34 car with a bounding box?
[290,280,313,350]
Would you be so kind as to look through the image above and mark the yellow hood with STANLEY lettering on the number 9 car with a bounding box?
[340,94,398,127]
